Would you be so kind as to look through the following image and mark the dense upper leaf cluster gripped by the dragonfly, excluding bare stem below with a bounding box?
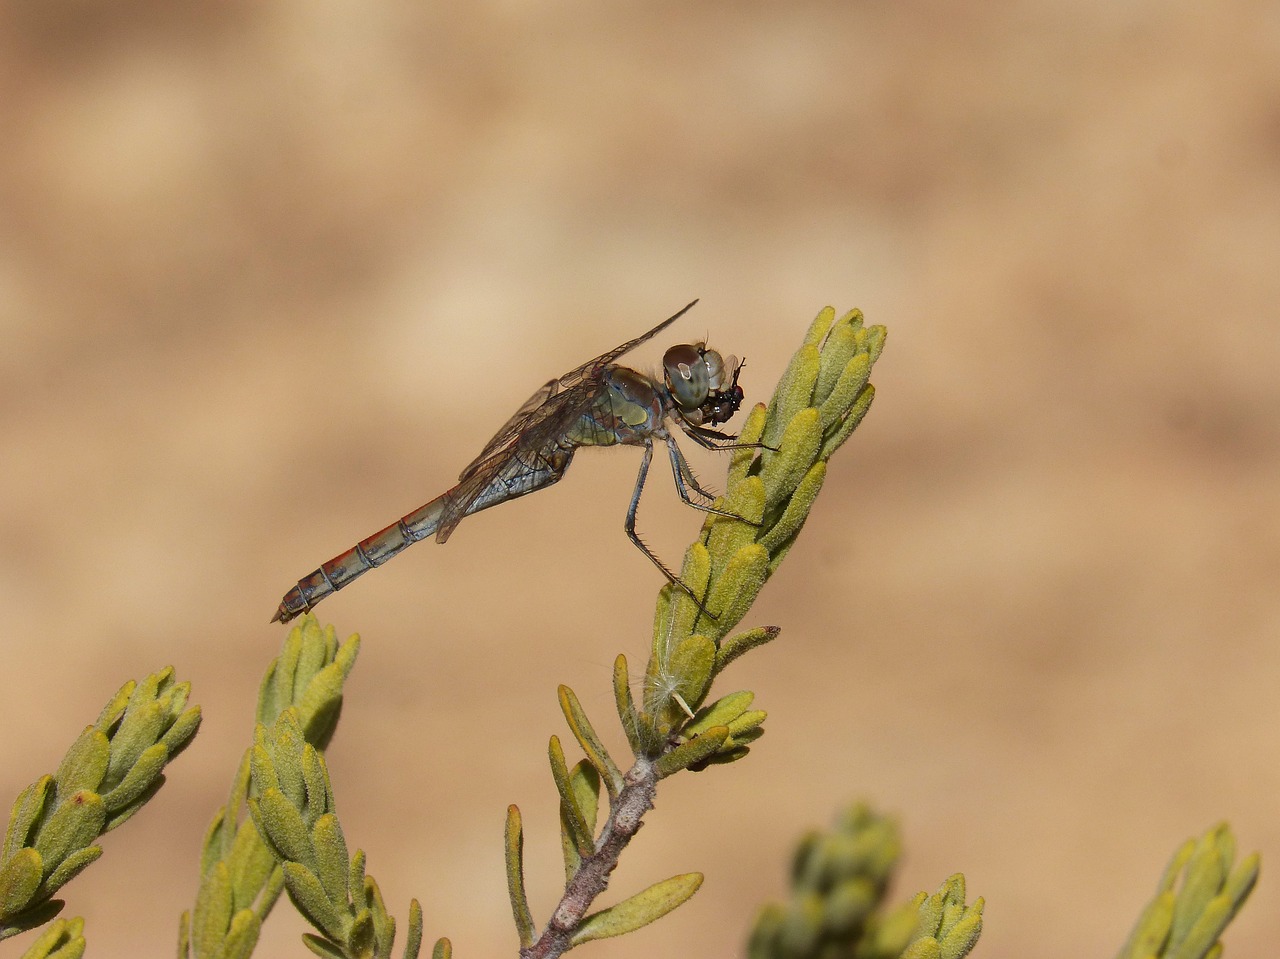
[634,307,884,757]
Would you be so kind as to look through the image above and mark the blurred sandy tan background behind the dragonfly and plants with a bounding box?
[0,0,1280,959]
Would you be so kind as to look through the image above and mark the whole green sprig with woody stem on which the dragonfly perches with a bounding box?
[507,307,884,959]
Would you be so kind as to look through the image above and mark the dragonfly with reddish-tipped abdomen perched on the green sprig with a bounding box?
[271,300,759,622]
